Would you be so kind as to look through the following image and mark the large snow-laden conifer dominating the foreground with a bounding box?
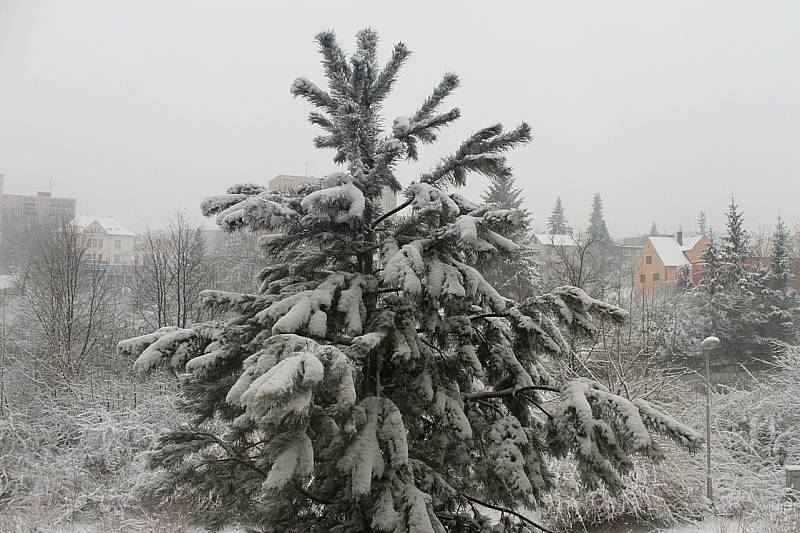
[120,30,700,533]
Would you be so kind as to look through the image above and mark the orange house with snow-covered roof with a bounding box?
[633,231,708,294]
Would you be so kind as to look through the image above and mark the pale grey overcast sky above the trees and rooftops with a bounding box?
[0,0,800,237]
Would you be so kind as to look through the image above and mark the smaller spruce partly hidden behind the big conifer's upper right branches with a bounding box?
[475,176,541,300]
